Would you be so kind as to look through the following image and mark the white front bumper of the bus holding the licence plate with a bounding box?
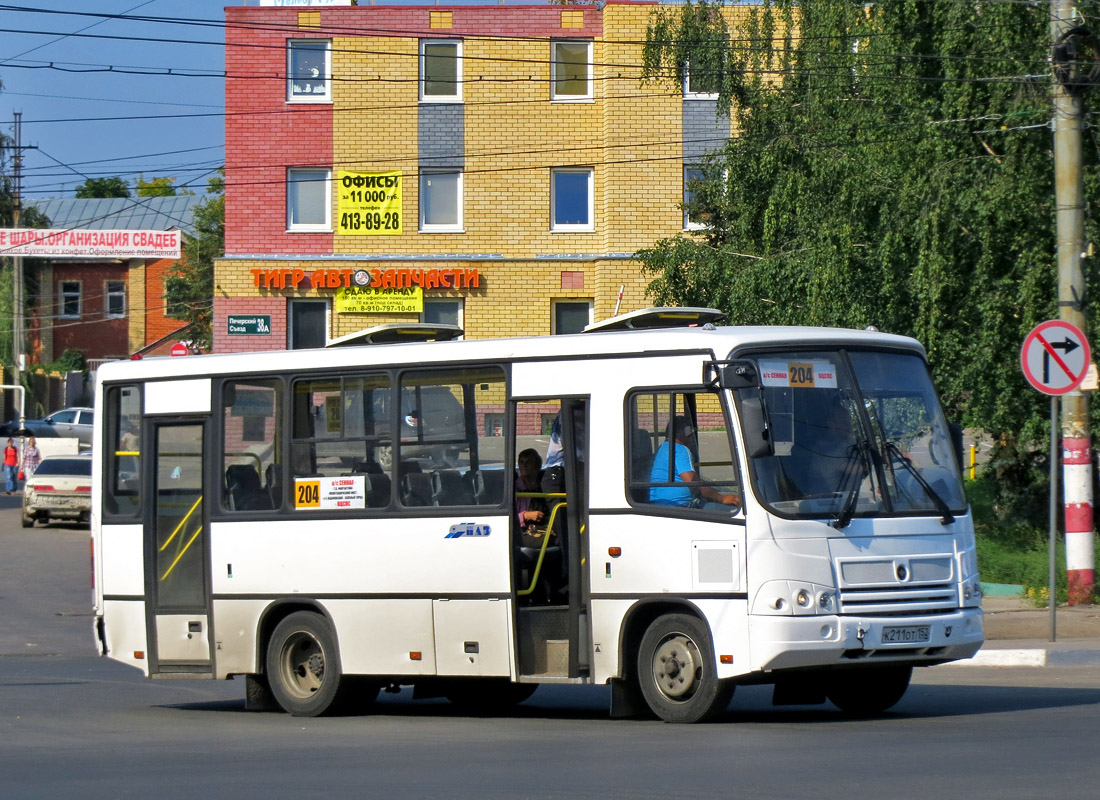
[749,609,985,670]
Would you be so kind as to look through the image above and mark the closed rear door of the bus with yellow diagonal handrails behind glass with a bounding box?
[144,420,213,677]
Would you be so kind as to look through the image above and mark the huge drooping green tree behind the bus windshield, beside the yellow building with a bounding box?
[640,0,1100,453]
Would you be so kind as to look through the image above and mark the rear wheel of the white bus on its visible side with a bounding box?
[266,611,343,716]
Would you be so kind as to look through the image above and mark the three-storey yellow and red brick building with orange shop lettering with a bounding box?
[215,2,737,351]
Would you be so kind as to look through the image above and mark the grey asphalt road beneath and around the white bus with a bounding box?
[0,496,1100,800]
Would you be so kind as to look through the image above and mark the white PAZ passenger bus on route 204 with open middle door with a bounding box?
[92,309,982,722]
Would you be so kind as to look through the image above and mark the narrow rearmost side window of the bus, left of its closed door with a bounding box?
[103,386,142,518]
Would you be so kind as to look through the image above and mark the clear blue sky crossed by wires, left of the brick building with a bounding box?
[0,0,229,201]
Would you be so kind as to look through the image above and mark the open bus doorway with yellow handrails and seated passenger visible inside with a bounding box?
[512,397,589,682]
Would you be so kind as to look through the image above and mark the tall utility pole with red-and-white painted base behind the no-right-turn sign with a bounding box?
[1051,0,1096,607]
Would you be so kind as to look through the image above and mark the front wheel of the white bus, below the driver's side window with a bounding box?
[638,614,735,722]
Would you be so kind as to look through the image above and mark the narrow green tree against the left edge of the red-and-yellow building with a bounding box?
[165,172,226,348]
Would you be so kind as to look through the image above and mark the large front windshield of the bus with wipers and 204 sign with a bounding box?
[740,350,966,519]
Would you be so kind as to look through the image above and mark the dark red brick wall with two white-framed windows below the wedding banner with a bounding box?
[50,262,132,359]
